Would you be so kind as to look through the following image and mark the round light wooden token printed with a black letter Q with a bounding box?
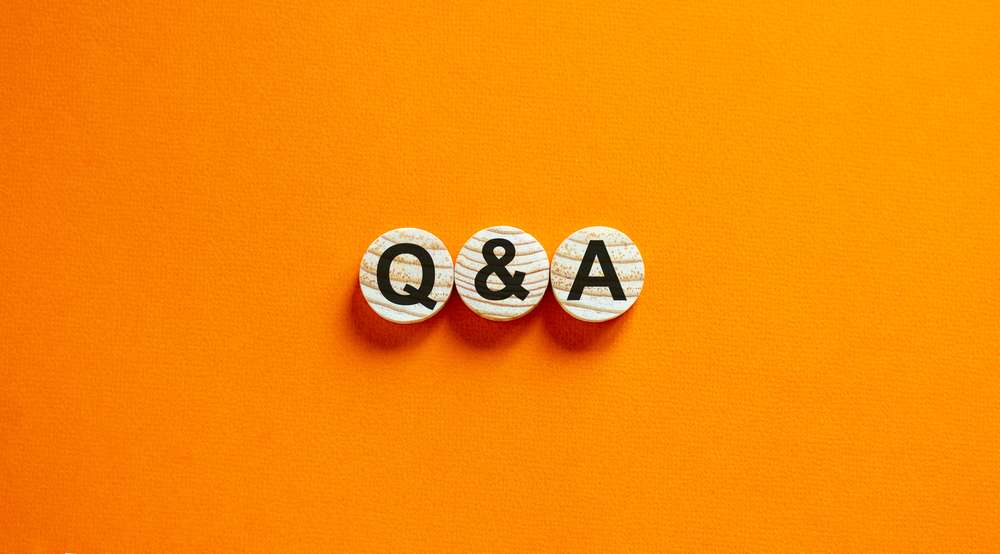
[359,227,455,323]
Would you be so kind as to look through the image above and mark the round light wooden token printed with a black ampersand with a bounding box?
[455,226,549,321]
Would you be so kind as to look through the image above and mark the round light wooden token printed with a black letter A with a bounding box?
[552,227,646,322]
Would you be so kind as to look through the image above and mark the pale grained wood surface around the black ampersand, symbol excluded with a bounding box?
[455,226,549,321]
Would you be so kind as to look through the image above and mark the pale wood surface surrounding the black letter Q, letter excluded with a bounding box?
[359,227,455,323]
